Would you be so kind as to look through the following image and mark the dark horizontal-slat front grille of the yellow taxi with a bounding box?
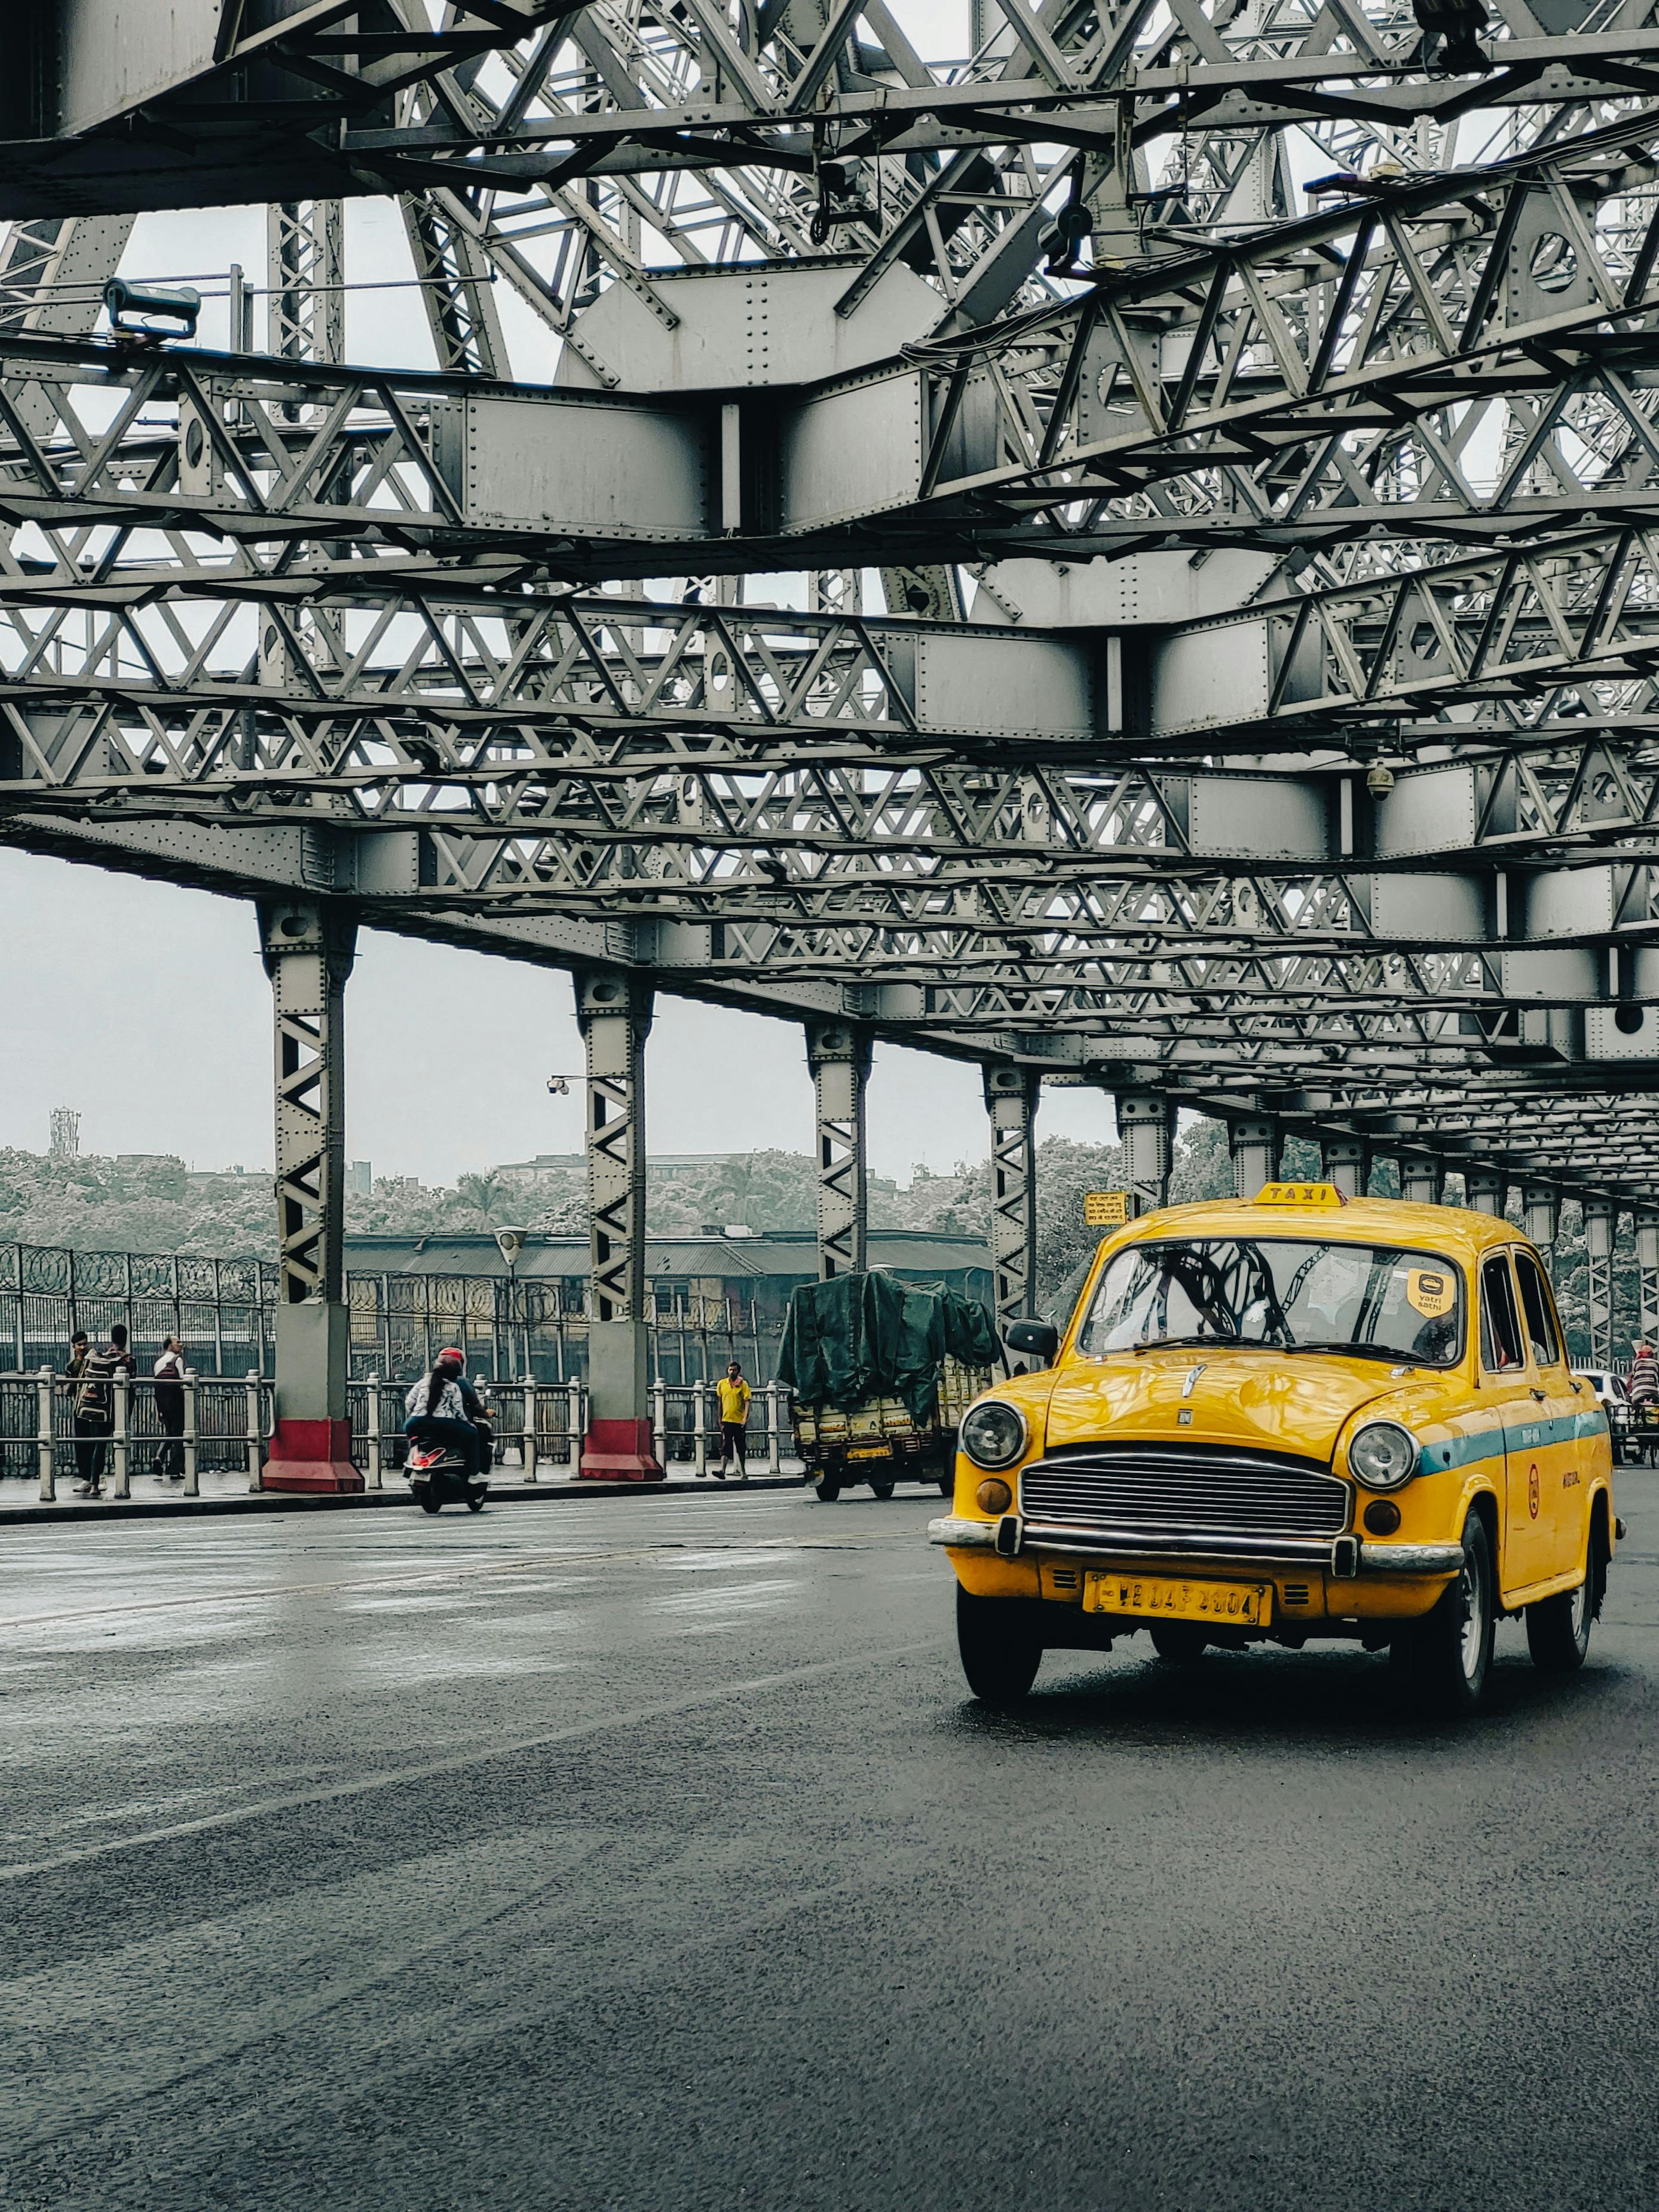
[1020,1445,1347,1537]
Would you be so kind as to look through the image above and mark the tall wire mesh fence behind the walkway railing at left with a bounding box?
[0,1243,779,1389]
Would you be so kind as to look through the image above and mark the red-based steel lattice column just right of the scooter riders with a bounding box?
[575,975,662,1482]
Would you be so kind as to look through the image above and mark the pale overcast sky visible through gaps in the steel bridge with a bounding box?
[0,78,1141,1183]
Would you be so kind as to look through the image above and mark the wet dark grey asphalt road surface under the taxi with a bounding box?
[0,1473,1659,2212]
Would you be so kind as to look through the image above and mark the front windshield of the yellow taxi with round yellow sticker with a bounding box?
[1078,1237,1464,1367]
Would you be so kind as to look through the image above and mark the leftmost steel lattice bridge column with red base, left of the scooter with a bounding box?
[259,900,363,1491]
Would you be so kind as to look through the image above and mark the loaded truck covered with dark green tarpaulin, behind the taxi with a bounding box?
[779,1272,1002,1504]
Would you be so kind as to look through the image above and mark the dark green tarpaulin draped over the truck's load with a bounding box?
[779,1274,997,1422]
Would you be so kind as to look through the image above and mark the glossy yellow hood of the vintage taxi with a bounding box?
[1046,1350,1425,1460]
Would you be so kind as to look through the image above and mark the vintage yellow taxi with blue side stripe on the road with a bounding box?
[929,1183,1624,1712]
